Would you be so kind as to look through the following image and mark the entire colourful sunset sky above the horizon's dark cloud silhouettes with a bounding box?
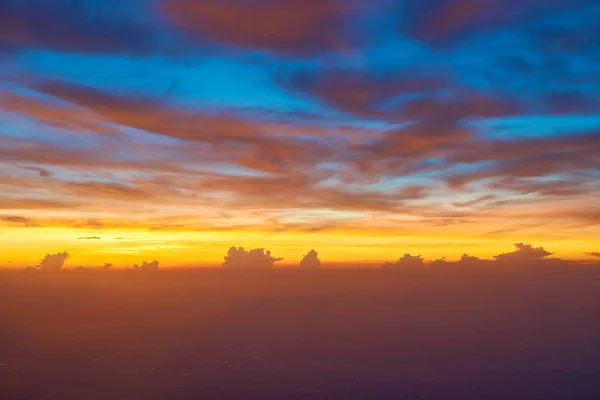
[0,0,600,267]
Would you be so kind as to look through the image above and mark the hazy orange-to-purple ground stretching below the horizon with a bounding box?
[0,266,600,400]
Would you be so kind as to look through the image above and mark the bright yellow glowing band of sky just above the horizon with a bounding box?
[0,227,599,268]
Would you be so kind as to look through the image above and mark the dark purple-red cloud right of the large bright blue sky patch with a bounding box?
[277,67,522,122]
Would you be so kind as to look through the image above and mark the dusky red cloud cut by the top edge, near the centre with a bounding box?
[160,0,353,55]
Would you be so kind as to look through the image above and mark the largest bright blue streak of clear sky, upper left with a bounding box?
[16,51,319,112]
